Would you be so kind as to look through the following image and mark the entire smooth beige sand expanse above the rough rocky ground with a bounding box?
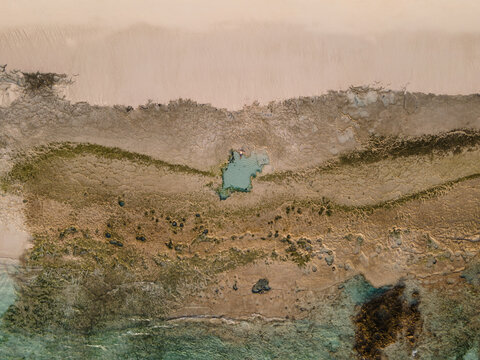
[0,0,480,109]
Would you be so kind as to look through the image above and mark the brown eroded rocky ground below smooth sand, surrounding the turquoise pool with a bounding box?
[0,69,480,359]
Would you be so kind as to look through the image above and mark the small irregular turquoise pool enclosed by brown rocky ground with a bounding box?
[219,151,269,200]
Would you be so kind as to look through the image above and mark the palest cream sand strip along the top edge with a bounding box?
[0,0,480,35]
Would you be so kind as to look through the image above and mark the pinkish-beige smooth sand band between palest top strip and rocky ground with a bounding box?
[0,23,480,111]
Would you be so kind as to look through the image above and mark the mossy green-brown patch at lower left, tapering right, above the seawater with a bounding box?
[4,227,266,333]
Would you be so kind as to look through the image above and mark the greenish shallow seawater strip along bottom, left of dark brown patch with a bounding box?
[0,321,353,360]
